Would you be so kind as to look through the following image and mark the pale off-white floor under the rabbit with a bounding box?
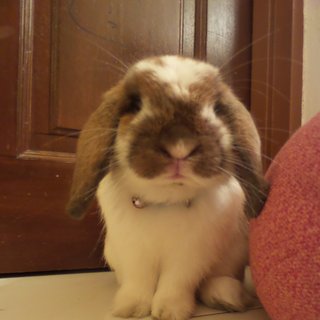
[0,272,269,320]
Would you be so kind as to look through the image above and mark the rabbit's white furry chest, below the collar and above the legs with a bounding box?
[97,176,244,278]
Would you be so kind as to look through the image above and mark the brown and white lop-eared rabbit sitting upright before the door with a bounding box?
[68,56,266,320]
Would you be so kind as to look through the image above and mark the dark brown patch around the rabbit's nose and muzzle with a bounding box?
[128,96,225,179]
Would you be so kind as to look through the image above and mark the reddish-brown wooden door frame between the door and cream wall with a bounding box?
[250,0,304,168]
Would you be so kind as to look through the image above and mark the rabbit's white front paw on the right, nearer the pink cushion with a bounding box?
[152,294,195,320]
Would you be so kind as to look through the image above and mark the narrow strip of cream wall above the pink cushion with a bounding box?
[302,0,320,123]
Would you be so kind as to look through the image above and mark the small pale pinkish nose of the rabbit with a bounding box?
[162,140,199,160]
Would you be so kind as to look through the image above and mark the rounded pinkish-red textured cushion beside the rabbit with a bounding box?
[250,113,320,320]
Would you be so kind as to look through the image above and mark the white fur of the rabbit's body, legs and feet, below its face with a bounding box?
[97,165,247,319]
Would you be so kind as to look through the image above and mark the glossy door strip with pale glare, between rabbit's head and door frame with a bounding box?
[206,0,252,109]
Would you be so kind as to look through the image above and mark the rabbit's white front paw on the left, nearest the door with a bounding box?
[112,288,152,318]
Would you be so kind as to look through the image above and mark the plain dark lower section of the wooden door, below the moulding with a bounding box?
[0,158,103,273]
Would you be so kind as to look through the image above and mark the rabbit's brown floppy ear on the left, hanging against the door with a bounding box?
[67,84,123,219]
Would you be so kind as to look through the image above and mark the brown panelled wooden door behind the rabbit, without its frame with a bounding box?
[0,0,272,273]
